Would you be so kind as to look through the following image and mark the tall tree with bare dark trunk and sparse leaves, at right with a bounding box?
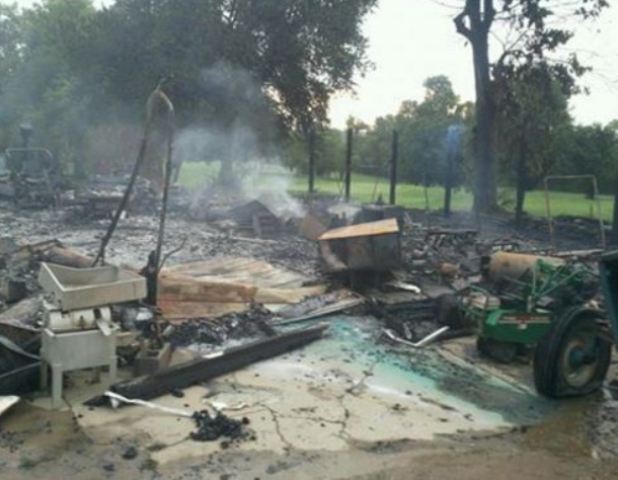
[454,0,608,211]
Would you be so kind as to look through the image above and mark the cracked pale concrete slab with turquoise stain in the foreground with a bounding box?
[60,317,548,468]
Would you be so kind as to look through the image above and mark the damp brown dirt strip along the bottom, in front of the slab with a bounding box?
[0,407,618,480]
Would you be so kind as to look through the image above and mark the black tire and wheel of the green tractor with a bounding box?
[533,307,612,398]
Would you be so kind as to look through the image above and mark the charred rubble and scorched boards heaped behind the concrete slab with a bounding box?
[0,172,598,441]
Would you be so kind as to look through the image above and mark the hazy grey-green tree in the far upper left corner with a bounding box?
[0,0,95,168]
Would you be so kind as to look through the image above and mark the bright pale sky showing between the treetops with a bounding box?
[0,0,618,128]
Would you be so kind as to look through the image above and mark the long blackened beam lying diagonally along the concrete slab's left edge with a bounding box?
[111,324,328,400]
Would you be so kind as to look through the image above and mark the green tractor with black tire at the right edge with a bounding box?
[464,252,618,398]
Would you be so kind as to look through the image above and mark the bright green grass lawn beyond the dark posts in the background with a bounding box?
[179,163,613,221]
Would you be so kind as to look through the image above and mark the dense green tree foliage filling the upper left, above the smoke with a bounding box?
[0,0,377,175]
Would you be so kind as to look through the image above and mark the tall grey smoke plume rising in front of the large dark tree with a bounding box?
[174,63,304,218]
